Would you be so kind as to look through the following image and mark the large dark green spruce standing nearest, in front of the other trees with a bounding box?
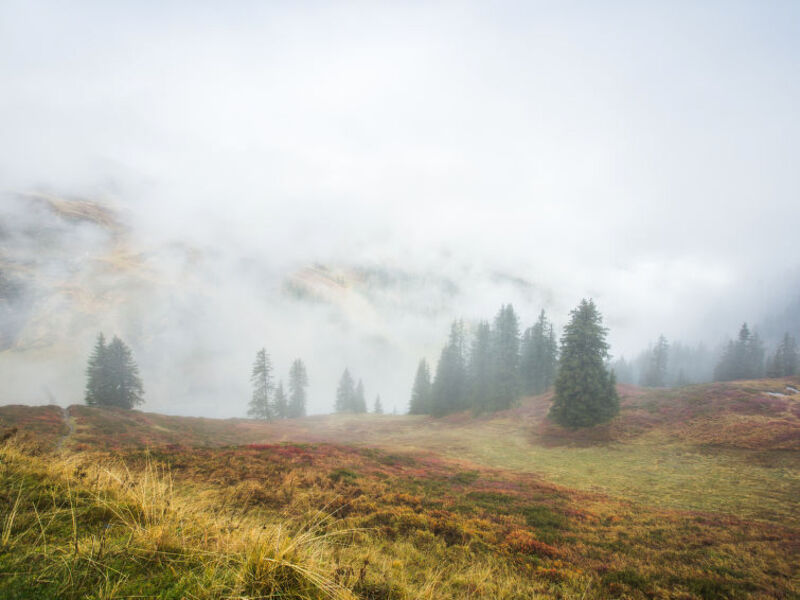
[549,299,619,428]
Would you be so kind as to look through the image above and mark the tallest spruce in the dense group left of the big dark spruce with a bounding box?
[490,304,520,410]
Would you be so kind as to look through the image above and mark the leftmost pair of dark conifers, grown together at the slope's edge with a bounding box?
[85,333,144,409]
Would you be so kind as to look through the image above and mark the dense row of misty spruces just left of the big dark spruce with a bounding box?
[409,304,558,416]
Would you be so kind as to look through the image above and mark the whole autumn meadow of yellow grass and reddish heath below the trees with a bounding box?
[0,379,800,599]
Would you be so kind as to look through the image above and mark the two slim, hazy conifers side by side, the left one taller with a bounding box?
[247,348,308,421]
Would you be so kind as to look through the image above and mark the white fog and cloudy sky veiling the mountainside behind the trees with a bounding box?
[0,0,800,416]
